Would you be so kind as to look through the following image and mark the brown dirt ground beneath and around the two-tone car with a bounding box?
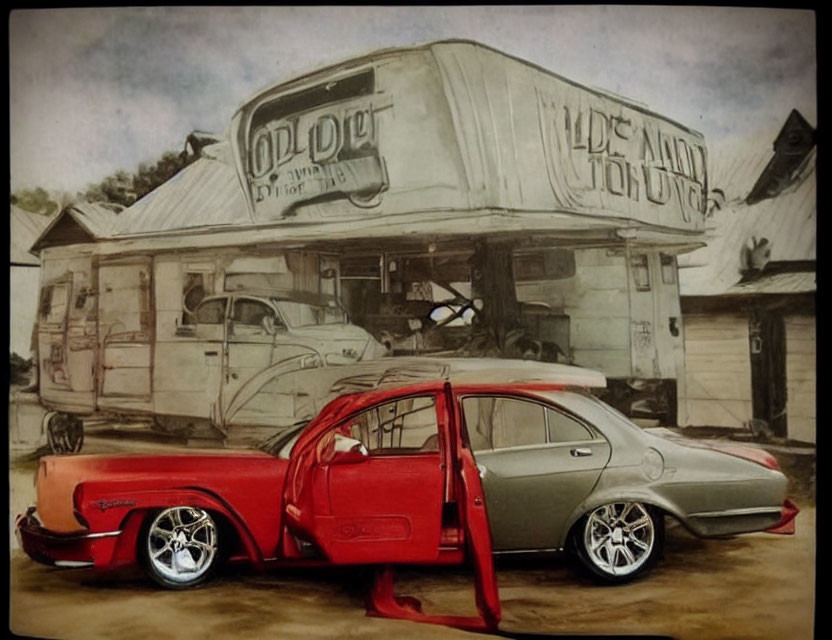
[10,438,815,640]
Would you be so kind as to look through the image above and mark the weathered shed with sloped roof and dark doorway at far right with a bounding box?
[680,111,817,442]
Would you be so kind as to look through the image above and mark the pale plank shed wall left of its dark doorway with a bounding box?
[679,314,753,428]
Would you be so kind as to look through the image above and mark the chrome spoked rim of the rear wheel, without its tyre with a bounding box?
[583,502,657,577]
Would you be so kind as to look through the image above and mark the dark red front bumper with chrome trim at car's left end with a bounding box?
[15,507,121,568]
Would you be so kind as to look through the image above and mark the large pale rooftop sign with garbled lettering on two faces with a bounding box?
[232,41,707,238]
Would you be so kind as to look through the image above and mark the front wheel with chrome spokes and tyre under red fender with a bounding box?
[139,506,219,589]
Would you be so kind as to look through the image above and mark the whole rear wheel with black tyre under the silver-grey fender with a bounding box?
[572,502,664,584]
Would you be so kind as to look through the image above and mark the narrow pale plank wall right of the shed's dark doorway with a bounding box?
[786,316,817,442]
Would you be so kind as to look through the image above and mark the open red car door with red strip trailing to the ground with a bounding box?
[284,384,500,630]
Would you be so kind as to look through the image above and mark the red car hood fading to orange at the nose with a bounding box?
[37,450,286,533]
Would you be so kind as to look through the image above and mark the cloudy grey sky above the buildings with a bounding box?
[9,5,817,192]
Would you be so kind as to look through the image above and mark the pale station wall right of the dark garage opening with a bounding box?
[517,249,631,377]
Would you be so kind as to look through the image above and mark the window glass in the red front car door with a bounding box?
[349,397,439,455]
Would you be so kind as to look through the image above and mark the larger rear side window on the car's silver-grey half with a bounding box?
[462,396,546,451]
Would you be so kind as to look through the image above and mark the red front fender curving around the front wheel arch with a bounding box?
[76,482,264,570]
